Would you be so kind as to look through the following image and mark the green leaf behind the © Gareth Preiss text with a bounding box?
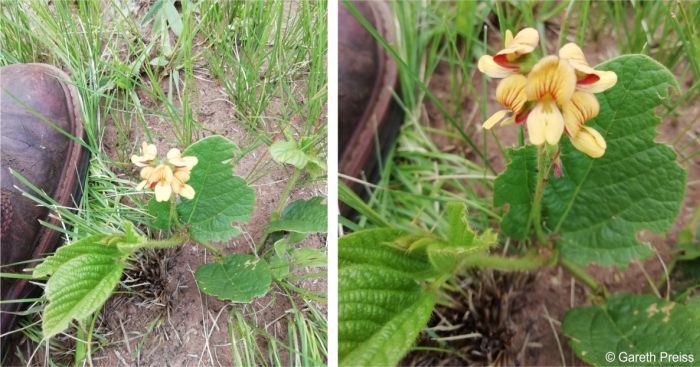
[562,294,700,366]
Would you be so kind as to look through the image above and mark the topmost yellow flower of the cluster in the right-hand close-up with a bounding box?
[478,28,540,78]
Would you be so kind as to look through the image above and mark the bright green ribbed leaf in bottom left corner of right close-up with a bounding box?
[338,228,435,366]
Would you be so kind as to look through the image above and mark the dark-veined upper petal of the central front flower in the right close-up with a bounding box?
[525,55,576,105]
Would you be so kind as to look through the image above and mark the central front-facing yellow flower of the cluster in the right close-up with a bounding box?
[525,56,576,145]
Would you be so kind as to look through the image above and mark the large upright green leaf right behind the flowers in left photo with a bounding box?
[177,135,255,241]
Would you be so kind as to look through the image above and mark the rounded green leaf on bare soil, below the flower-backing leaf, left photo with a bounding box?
[194,254,272,303]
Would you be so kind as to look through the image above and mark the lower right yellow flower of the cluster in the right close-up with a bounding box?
[562,91,606,158]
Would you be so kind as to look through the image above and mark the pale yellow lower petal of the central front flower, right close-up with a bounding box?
[527,102,564,145]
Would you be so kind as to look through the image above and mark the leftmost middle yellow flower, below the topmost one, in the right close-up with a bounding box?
[483,74,527,129]
